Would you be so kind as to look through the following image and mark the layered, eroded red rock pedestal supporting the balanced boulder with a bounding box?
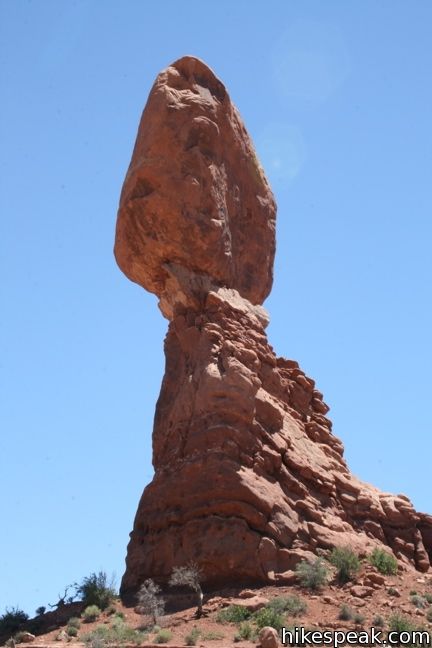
[121,289,432,597]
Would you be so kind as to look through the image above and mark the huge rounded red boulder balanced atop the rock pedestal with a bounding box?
[115,56,276,316]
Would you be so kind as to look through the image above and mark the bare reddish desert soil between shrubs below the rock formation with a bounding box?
[9,564,432,648]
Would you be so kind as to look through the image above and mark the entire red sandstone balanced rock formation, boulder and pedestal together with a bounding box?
[115,57,432,597]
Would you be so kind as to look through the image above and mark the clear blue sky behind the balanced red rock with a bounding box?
[0,0,432,613]
